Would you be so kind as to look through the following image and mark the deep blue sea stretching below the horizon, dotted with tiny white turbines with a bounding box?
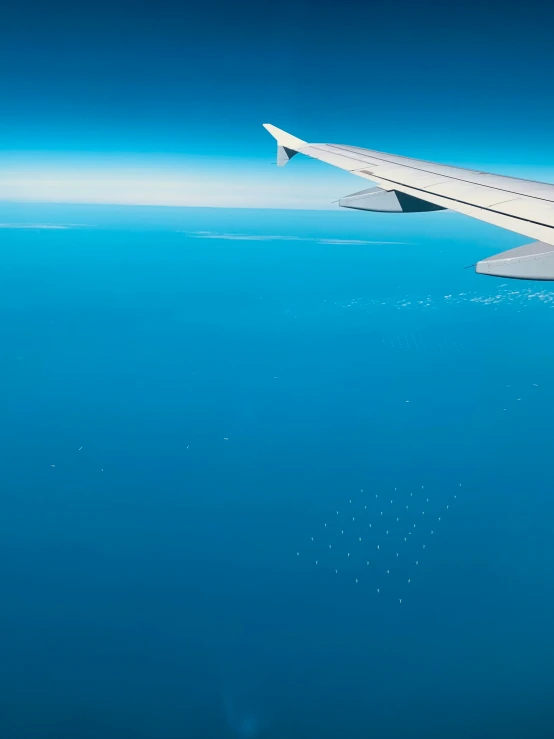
[0,204,554,739]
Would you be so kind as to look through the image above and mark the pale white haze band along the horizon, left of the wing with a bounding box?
[0,161,360,210]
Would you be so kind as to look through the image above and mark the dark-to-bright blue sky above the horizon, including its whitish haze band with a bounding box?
[0,0,554,208]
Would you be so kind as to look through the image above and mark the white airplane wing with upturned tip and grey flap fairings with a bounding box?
[263,123,554,280]
